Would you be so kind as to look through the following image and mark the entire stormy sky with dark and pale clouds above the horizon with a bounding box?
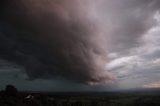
[0,0,160,91]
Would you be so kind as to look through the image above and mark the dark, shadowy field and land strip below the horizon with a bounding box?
[0,85,160,106]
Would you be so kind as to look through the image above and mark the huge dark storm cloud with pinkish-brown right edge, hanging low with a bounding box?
[0,0,112,83]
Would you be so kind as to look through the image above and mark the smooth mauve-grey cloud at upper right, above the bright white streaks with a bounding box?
[98,0,160,52]
